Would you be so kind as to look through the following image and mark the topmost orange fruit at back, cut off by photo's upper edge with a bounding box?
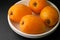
[29,0,48,14]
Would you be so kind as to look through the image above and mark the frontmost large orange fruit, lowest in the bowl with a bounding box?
[20,15,46,34]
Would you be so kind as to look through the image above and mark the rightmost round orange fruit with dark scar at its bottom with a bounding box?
[40,6,59,26]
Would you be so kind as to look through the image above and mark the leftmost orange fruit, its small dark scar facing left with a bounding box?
[8,4,32,23]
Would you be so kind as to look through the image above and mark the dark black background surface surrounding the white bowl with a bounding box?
[0,0,60,40]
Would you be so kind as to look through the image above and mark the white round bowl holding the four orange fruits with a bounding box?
[8,0,59,38]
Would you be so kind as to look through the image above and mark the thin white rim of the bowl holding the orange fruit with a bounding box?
[8,1,59,36]
